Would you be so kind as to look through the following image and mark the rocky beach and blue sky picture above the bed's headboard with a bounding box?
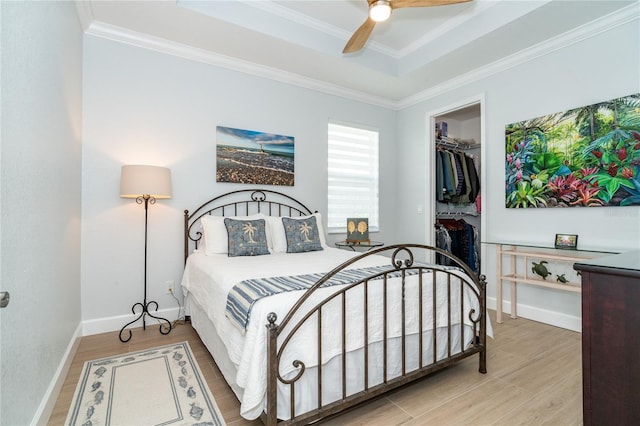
[216,126,294,186]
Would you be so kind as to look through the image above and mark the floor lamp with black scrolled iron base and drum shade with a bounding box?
[119,165,171,343]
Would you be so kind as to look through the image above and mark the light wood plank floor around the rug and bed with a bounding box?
[48,311,582,426]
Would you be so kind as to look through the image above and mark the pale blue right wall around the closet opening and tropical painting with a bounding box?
[398,16,640,326]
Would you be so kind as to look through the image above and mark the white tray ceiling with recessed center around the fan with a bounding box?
[78,0,640,105]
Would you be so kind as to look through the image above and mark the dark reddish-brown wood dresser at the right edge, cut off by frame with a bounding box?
[574,251,640,425]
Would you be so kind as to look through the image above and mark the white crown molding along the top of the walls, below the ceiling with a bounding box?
[84,1,640,110]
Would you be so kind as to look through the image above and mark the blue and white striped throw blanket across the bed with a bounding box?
[226,262,468,332]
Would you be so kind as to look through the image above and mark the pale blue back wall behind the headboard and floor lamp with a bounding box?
[82,36,397,333]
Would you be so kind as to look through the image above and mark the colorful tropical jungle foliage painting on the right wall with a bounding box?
[505,94,640,208]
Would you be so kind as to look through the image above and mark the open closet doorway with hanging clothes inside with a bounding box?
[426,96,486,273]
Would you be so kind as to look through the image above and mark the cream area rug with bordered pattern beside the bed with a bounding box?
[65,342,225,426]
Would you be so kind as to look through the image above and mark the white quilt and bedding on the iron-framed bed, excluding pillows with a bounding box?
[182,248,491,419]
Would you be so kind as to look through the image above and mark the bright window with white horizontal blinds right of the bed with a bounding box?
[327,123,378,233]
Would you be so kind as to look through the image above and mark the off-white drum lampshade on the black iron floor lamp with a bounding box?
[120,165,171,199]
